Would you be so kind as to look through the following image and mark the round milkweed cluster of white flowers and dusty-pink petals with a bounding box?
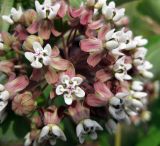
[0,0,153,146]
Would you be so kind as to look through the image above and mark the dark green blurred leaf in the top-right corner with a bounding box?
[138,0,160,23]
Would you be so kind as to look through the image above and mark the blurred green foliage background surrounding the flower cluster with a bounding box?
[0,0,160,146]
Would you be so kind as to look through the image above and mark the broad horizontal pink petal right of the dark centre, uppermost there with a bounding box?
[80,39,103,52]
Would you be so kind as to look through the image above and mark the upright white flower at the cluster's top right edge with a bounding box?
[102,2,125,22]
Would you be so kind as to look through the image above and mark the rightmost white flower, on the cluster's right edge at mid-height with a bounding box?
[137,61,153,78]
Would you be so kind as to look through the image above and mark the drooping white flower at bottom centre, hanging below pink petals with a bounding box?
[76,119,103,144]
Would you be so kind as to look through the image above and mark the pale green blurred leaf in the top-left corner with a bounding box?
[0,0,14,31]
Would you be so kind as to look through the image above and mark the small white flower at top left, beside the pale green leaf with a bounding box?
[2,7,23,24]
